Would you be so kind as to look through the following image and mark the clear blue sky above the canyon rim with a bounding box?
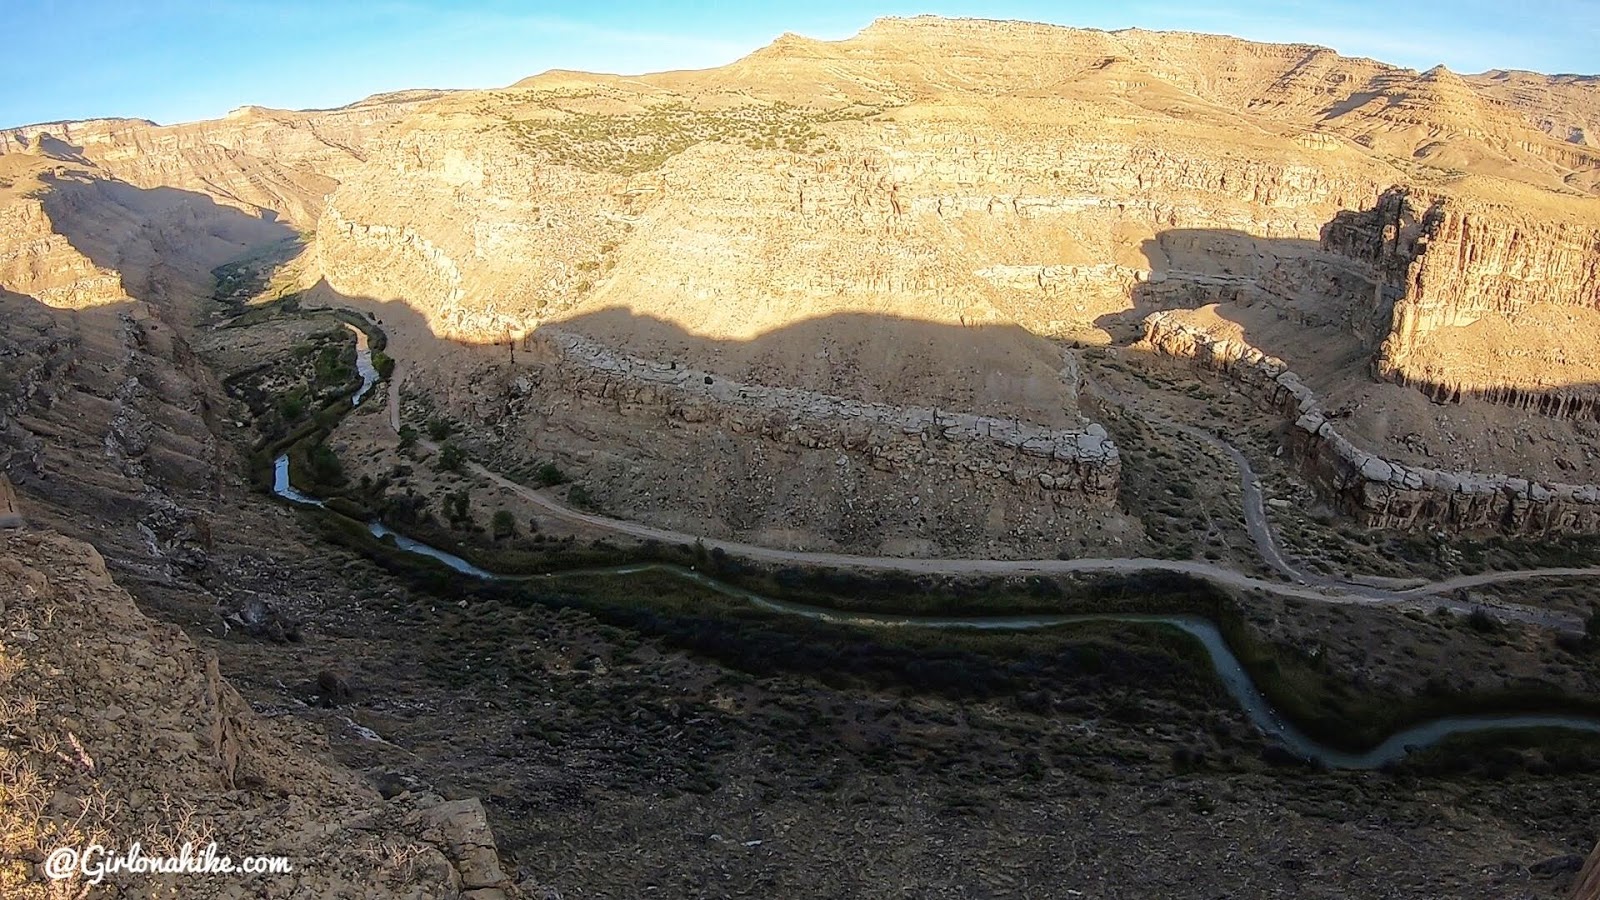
[0,0,1600,127]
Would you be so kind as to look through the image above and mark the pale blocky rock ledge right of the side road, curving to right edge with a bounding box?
[1144,312,1600,533]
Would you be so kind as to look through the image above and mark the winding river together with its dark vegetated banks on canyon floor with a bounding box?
[240,312,1600,767]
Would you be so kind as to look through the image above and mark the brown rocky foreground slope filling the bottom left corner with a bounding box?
[0,532,515,900]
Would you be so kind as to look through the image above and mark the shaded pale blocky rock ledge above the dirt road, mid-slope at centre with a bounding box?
[538,330,1122,504]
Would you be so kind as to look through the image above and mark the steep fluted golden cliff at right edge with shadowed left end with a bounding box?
[1323,191,1600,418]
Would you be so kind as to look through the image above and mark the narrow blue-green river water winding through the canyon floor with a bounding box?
[272,325,1600,769]
